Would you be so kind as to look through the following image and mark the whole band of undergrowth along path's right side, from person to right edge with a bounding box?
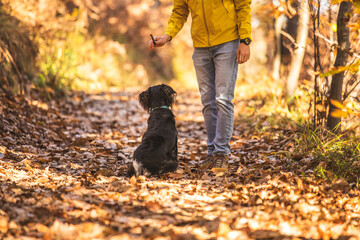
[235,77,360,187]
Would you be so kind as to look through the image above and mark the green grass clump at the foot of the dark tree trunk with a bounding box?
[296,127,360,187]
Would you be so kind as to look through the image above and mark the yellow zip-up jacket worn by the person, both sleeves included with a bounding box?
[165,0,251,47]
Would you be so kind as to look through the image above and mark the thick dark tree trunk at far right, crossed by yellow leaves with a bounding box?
[327,2,351,132]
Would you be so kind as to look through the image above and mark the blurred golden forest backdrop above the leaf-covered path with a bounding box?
[0,0,360,124]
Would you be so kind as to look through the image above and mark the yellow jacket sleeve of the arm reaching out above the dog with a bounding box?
[165,0,189,38]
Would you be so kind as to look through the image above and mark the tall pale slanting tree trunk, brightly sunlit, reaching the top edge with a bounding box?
[286,0,310,101]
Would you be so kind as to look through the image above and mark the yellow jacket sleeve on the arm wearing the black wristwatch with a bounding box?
[234,0,251,39]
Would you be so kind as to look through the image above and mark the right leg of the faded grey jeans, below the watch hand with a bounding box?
[212,40,239,155]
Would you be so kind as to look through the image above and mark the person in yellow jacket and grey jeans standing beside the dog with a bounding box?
[148,0,251,171]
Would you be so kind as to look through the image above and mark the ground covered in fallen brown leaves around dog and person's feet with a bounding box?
[0,90,360,240]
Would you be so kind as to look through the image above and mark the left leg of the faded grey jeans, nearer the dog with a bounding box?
[193,48,217,155]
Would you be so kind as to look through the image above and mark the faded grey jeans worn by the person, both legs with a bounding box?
[193,40,239,155]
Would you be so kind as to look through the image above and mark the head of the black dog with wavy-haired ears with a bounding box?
[139,84,176,112]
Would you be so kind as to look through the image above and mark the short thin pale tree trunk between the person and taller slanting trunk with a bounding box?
[272,14,285,81]
